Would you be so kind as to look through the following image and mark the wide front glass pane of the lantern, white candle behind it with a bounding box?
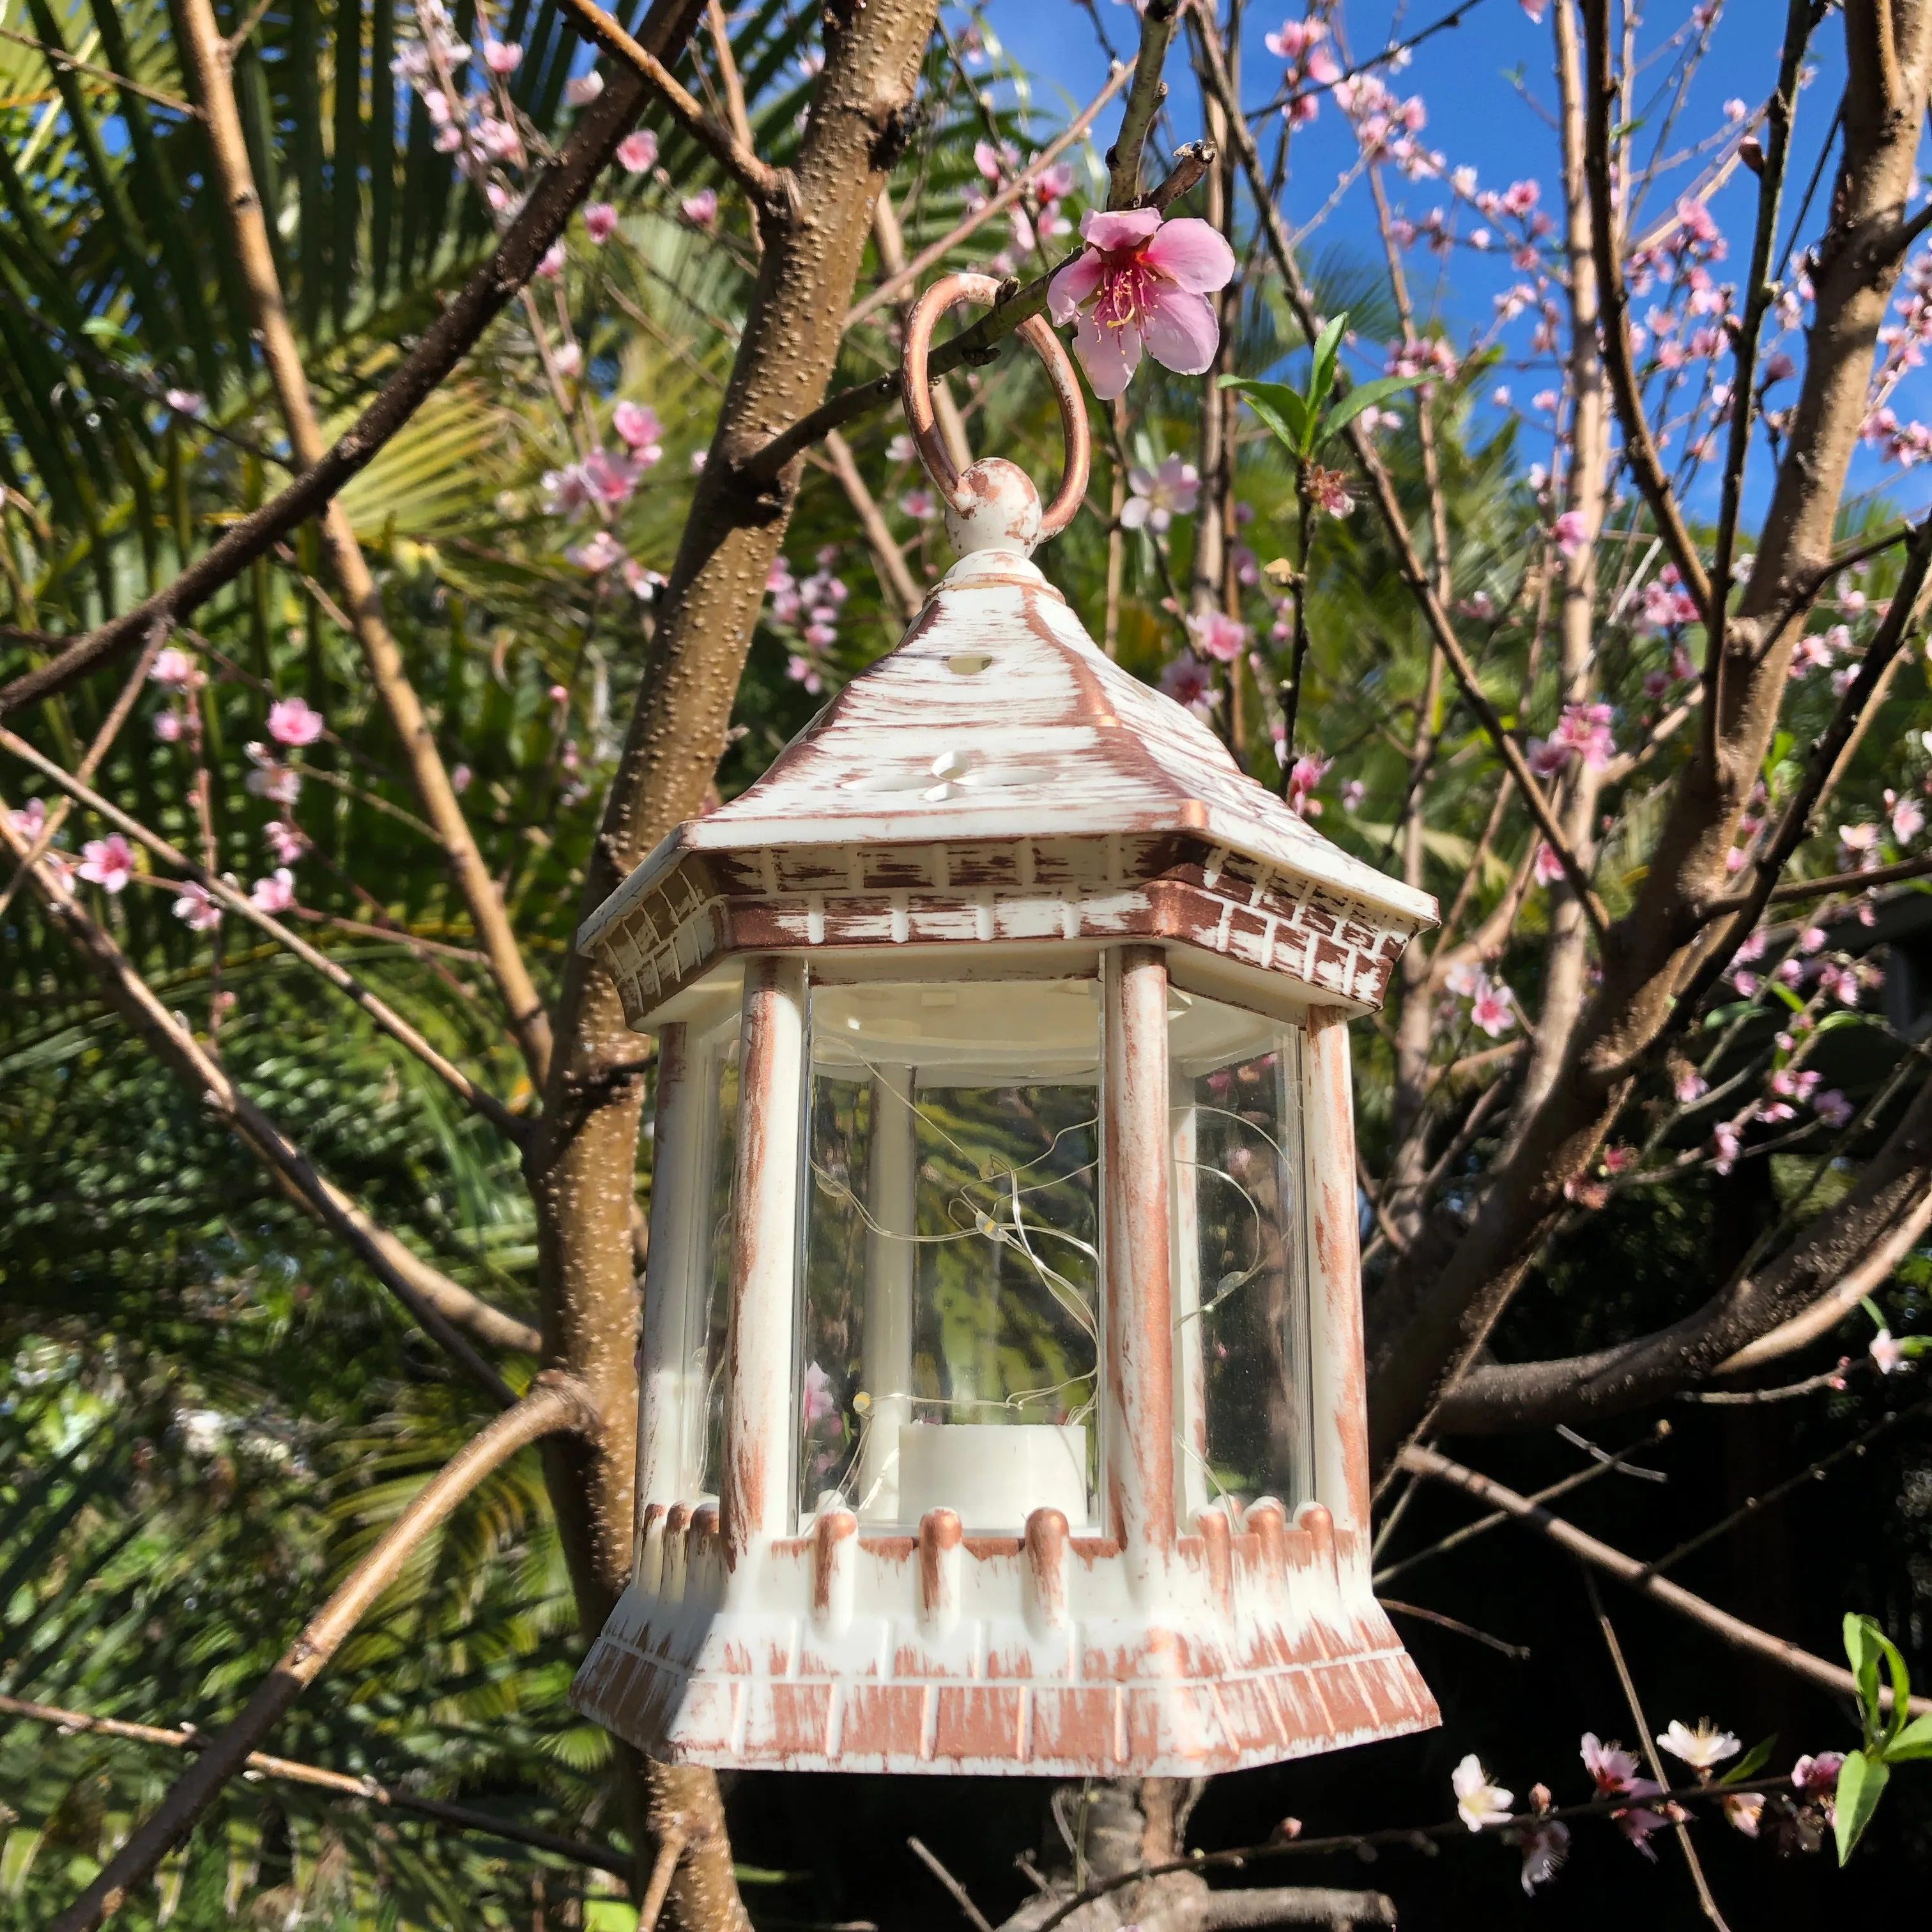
[794,979,1100,1532]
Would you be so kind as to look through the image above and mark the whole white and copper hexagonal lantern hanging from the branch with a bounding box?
[574,276,1438,1775]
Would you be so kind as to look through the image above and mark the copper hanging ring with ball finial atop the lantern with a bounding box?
[898,272,1092,551]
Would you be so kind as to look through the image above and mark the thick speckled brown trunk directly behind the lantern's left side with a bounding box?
[526,0,935,1932]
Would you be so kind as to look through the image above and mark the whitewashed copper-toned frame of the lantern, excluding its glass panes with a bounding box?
[572,276,1438,1777]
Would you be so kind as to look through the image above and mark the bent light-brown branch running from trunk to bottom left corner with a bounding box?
[49,1372,597,1932]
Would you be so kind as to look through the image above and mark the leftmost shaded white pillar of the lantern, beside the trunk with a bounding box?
[638,1024,711,1511]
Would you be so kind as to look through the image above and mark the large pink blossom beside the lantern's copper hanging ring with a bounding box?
[1047,209,1234,402]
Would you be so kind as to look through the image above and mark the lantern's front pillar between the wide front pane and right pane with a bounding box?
[1101,945,1175,1592]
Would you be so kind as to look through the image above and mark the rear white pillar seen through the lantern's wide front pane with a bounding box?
[854,1066,919,1522]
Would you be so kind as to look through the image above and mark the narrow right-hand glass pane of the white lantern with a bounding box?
[1169,993,1314,1519]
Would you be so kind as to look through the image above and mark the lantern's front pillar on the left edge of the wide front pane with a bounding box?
[719,956,806,1567]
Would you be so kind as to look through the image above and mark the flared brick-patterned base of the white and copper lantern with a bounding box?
[570,1499,1439,1777]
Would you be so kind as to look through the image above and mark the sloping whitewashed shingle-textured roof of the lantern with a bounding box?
[578,551,1438,974]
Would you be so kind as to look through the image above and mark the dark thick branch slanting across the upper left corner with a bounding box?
[0,0,698,717]
